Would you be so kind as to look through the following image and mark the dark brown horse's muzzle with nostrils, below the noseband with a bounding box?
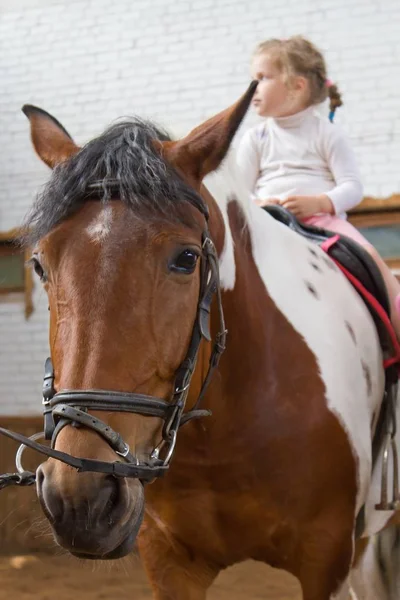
[37,460,144,560]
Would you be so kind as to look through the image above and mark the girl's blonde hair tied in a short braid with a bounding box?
[254,35,343,120]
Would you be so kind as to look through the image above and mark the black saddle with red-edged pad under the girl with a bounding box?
[263,204,400,524]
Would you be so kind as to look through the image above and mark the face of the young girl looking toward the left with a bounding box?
[251,54,307,117]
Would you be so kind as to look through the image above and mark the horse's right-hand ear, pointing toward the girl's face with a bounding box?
[162,81,258,184]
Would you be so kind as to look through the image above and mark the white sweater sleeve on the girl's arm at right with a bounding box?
[325,124,363,215]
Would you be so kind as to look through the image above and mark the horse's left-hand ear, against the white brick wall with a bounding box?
[22,104,79,169]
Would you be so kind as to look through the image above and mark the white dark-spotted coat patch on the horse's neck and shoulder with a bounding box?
[207,152,388,532]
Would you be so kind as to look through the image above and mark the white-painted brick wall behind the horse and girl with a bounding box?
[0,0,400,414]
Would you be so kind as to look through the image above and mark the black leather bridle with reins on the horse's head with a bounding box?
[0,181,227,489]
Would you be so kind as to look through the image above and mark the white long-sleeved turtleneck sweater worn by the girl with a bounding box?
[237,106,363,218]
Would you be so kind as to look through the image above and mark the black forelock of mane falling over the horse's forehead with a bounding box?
[24,118,206,245]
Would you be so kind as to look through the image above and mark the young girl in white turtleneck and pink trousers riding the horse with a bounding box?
[237,36,400,339]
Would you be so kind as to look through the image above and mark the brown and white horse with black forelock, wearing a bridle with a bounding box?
[19,83,400,600]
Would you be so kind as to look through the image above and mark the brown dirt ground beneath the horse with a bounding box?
[0,554,301,600]
